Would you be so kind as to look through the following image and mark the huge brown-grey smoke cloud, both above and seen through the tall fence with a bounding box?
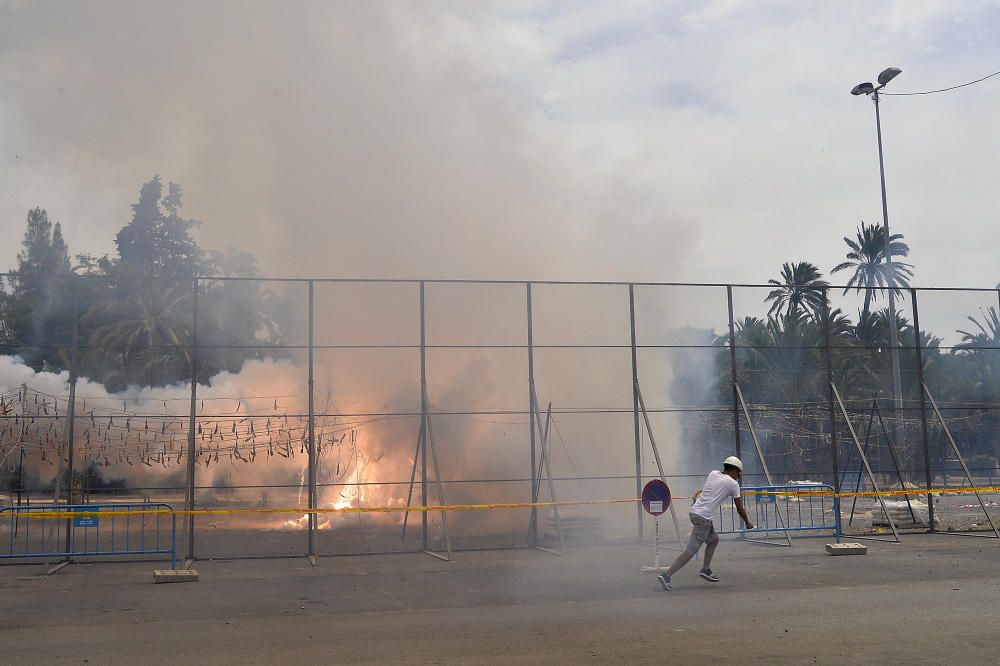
[4,2,720,540]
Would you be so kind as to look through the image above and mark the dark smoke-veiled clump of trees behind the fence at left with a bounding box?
[0,176,294,390]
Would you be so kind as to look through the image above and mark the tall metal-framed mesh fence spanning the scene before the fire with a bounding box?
[0,276,1000,559]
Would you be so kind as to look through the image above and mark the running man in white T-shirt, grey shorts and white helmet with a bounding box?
[656,456,753,591]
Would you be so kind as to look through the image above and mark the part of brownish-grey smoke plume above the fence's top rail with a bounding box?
[4,2,691,279]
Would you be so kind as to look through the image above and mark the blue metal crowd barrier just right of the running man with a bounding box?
[718,483,840,543]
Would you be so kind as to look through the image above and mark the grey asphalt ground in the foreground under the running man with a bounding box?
[0,535,1000,664]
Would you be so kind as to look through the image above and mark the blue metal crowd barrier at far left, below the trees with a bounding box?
[0,502,177,569]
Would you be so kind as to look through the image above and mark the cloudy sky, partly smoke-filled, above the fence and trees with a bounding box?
[0,0,1000,296]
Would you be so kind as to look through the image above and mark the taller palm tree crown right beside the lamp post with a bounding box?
[831,221,913,321]
